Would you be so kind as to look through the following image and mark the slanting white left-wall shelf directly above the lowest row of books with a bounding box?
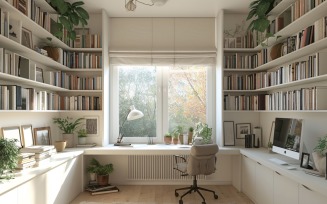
[0,73,67,91]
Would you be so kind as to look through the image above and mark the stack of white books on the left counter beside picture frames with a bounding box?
[20,145,57,167]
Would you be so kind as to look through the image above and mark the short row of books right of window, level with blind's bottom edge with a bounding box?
[224,53,259,69]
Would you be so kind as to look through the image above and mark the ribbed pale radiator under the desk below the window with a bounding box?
[128,155,205,180]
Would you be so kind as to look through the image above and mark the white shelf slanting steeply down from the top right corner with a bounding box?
[255,0,327,50]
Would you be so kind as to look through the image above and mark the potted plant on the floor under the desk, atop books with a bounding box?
[90,158,114,186]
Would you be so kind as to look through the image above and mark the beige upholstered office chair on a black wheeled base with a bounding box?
[174,144,219,204]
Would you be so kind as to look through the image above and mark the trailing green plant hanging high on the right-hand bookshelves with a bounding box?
[246,0,279,47]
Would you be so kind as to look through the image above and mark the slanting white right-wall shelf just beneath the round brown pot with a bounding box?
[254,37,327,71]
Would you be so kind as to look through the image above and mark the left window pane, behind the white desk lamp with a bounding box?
[119,66,157,137]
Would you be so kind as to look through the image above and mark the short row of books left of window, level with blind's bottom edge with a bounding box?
[60,51,102,69]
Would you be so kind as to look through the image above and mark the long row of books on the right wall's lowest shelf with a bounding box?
[224,86,327,110]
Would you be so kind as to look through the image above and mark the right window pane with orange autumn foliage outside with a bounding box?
[168,66,207,132]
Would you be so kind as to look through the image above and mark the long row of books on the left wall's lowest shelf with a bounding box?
[0,85,102,110]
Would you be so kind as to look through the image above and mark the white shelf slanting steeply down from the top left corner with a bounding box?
[0,0,69,49]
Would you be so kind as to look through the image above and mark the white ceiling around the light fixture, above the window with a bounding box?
[78,0,253,17]
